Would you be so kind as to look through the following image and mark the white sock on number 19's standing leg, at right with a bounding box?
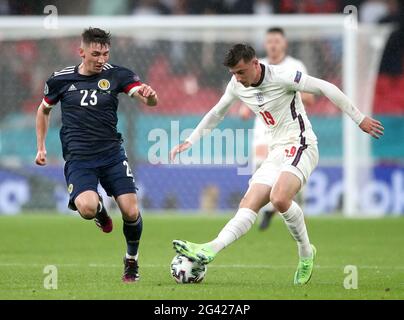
[281,201,313,258]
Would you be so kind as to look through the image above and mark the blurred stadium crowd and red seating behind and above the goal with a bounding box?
[0,0,404,124]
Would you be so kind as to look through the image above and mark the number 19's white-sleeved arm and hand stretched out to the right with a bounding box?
[302,76,384,139]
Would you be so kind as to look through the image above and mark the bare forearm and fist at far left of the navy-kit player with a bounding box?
[35,102,51,166]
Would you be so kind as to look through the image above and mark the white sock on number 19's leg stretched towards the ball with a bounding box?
[209,208,257,253]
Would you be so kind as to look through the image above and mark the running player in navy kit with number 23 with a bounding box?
[35,28,158,282]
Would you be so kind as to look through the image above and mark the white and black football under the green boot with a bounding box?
[171,255,207,283]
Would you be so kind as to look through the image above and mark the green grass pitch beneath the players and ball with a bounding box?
[0,214,404,299]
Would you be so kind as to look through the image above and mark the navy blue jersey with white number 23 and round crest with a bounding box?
[43,63,141,161]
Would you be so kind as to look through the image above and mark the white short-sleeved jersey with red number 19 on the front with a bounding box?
[227,63,317,148]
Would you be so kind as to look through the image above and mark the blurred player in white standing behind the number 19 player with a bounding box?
[240,27,314,230]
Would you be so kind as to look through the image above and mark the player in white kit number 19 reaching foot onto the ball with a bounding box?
[170,44,384,285]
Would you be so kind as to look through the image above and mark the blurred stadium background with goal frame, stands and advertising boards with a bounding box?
[0,0,404,215]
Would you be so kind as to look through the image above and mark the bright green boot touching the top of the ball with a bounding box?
[173,240,216,264]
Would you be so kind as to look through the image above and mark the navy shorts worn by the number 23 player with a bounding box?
[64,148,137,210]
